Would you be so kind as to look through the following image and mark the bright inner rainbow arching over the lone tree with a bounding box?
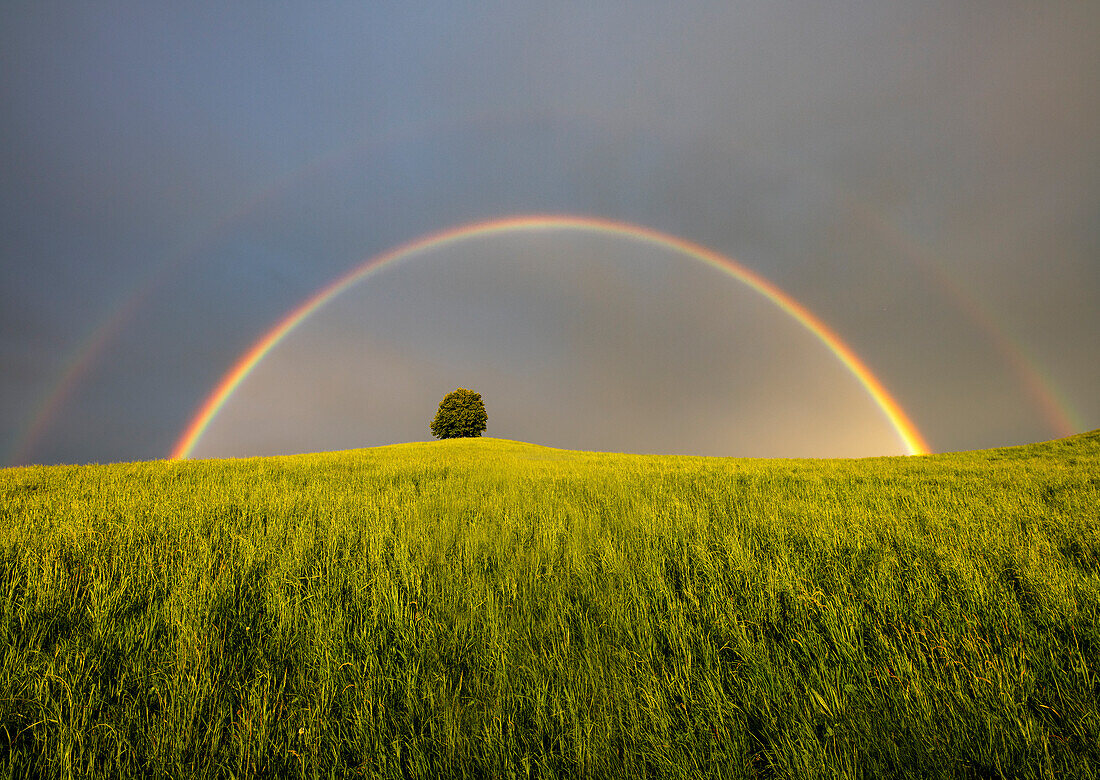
[169,215,928,459]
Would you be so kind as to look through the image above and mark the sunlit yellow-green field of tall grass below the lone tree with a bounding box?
[0,431,1100,778]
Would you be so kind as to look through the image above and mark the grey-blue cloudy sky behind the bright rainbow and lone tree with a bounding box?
[0,0,1100,464]
